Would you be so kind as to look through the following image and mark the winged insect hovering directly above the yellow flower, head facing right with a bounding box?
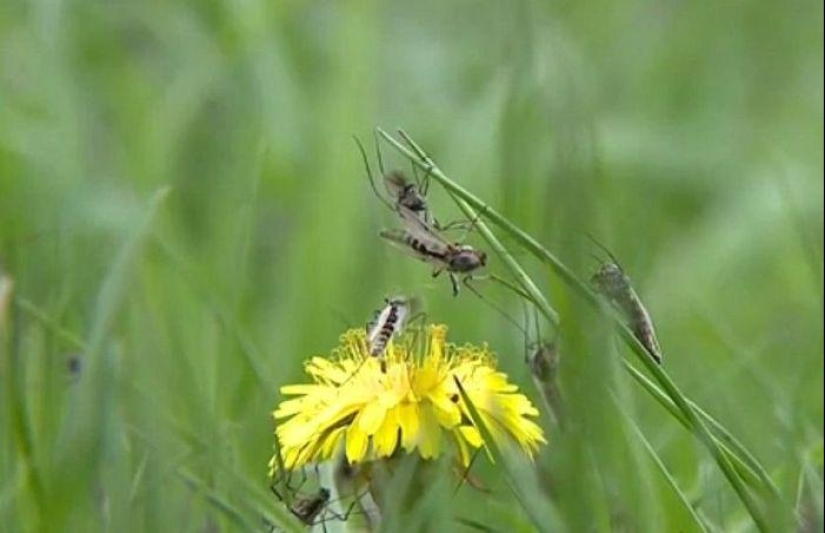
[379,207,487,296]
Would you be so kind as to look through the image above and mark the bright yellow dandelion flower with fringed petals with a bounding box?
[270,325,546,472]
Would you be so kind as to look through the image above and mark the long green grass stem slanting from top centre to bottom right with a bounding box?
[378,129,770,531]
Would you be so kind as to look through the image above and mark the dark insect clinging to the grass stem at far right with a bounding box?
[590,238,662,364]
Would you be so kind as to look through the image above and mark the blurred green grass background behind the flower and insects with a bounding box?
[0,0,823,531]
